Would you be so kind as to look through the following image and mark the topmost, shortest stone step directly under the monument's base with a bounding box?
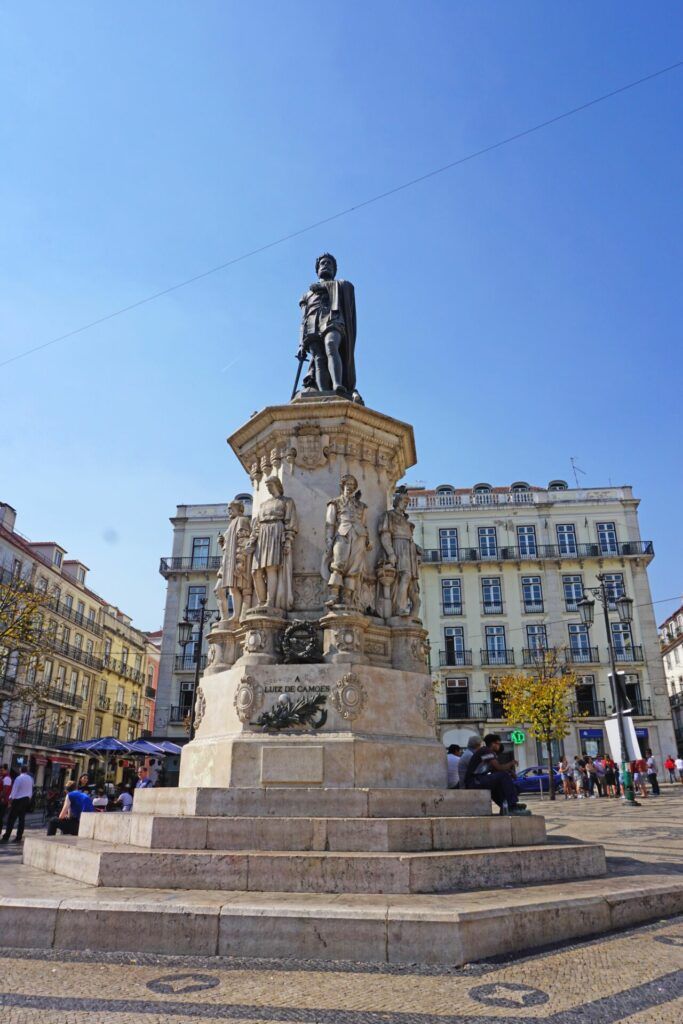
[133,786,490,818]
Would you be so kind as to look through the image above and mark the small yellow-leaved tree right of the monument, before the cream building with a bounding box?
[499,649,577,800]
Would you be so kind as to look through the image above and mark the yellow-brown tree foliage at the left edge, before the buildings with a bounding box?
[0,569,56,731]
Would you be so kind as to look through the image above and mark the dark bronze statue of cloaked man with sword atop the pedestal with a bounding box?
[298,253,362,404]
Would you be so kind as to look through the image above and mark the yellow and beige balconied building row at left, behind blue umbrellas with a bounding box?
[0,503,154,787]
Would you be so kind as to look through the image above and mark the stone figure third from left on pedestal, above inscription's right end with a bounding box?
[323,474,372,609]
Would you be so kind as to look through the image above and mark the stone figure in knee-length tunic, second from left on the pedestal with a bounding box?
[246,476,298,611]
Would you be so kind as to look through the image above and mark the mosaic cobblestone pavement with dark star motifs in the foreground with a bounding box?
[0,918,683,1024]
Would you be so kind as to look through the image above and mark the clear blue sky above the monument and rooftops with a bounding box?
[0,0,683,629]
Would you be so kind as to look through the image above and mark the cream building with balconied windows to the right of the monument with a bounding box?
[409,480,674,767]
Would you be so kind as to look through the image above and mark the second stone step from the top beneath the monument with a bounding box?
[79,814,546,853]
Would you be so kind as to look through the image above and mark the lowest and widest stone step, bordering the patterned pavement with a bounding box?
[0,864,683,967]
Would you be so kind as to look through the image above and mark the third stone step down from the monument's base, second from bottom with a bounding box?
[24,837,606,893]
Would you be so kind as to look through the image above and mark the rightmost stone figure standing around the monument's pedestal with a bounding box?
[378,487,422,618]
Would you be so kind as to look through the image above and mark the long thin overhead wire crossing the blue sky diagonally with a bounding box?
[0,60,683,367]
